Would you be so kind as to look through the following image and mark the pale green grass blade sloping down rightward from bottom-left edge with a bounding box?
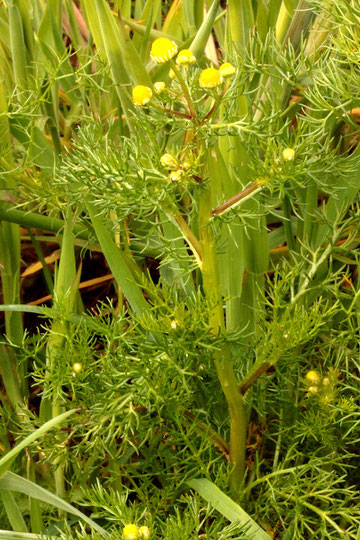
[0,472,109,538]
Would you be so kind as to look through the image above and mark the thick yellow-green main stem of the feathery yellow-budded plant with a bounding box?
[199,167,247,489]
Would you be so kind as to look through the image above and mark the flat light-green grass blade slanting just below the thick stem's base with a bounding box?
[186,478,271,540]
